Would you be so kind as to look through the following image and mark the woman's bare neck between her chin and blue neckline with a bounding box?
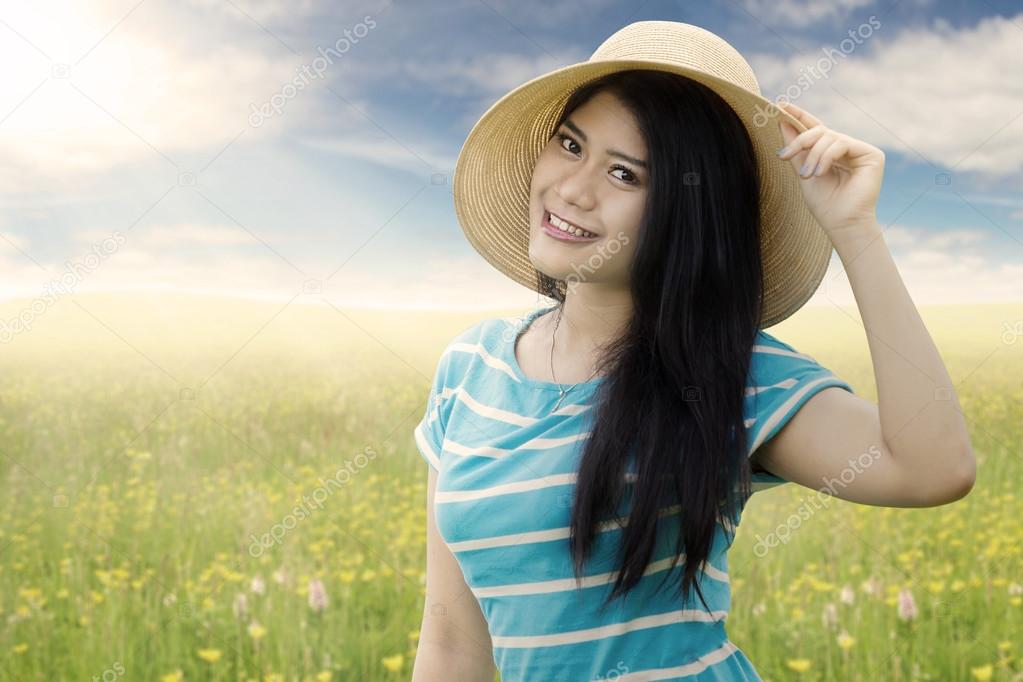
[557,283,632,357]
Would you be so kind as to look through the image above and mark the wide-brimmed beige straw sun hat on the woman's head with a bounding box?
[452,21,832,328]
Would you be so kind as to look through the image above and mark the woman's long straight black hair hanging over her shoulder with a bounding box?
[537,71,763,610]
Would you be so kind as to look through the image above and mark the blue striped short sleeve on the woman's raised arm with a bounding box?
[746,331,854,492]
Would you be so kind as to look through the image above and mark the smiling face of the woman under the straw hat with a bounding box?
[529,92,650,287]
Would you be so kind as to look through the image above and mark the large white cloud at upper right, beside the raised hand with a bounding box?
[750,14,1023,175]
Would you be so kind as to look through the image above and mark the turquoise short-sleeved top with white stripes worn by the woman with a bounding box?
[414,308,852,682]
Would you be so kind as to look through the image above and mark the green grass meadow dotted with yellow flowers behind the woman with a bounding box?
[0,294,1023,682]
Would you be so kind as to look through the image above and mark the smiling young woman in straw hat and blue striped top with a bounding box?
[413,21,975,682]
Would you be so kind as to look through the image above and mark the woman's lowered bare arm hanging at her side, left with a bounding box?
[412,467,497,682]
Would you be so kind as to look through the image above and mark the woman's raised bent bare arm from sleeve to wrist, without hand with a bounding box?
[752,224,976,507]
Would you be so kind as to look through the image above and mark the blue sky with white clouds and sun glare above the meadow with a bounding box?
[0,0,1023,308]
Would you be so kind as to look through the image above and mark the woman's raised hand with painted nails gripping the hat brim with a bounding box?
[777,102,885,242]
